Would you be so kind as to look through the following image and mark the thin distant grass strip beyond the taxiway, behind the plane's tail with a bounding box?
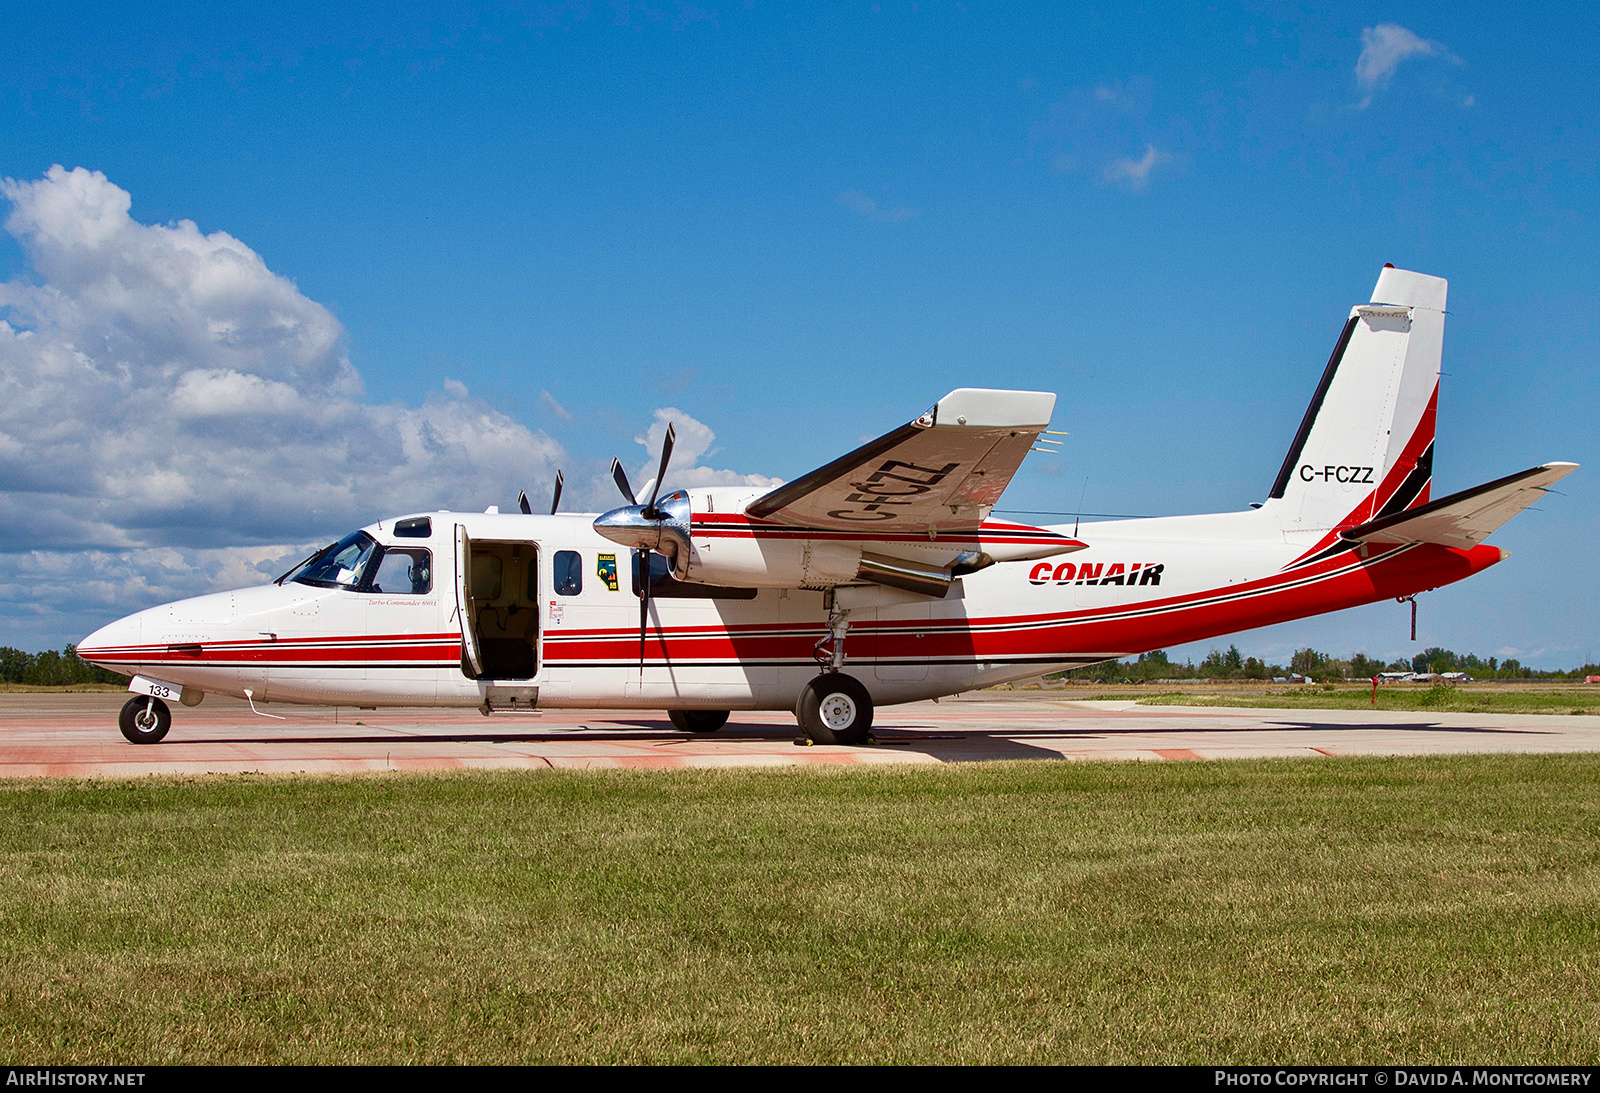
[1070,683,1600,714]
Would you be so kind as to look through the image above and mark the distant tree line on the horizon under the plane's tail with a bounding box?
[1062,645,1600,683]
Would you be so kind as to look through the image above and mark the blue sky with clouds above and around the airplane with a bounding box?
[0,0,1600,666]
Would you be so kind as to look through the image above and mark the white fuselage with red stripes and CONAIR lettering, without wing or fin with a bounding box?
[80,505,1502,709]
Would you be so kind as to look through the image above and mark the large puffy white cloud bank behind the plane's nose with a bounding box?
[0,166,776,648]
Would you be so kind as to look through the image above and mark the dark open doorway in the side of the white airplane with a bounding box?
[459,539,539,680]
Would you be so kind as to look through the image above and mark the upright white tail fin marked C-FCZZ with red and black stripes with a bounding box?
[1264,266,1446,546]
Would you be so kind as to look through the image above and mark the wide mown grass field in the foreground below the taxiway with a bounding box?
[0,755,1600,1064]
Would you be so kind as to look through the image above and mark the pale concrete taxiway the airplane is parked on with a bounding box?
[0,691,1600,778]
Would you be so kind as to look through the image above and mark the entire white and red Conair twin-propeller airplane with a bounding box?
[78,267,1574,743]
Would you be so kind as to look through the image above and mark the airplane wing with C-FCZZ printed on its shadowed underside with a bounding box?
[744,387,1056,533]
